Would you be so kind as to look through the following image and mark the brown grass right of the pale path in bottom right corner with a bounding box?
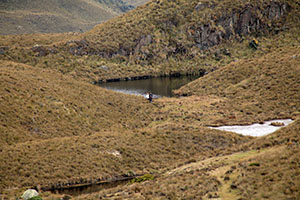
[232,144,300,199]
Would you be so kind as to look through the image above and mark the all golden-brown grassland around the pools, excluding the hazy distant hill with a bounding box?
[0,0,300,199]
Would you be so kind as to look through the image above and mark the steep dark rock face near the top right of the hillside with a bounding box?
[188,2,290,50]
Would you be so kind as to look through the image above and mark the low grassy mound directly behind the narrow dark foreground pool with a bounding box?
[0,124,250,191]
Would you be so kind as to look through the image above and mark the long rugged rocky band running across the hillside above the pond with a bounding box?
[66,1,291,64]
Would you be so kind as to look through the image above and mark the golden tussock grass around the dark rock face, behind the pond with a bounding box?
[0,0,299,81]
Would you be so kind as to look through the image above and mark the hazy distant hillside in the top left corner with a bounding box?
[0,0,133,35]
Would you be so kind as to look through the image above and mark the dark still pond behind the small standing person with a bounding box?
[99,76,199,98]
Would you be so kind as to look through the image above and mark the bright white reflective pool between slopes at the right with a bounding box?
[210,119,293,137]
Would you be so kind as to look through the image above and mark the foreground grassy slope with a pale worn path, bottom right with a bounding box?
[73,119,300,200]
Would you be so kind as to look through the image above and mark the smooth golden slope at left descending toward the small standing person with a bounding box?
[0,61,151,144]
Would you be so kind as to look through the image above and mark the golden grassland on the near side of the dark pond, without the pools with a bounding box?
[0,41,300,199]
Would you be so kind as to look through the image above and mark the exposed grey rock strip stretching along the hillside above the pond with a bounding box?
[69,1,291,63]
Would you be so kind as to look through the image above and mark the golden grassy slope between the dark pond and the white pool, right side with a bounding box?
[176,46,300,124]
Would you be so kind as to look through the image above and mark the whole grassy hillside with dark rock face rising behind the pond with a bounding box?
[0,0,299,82]
